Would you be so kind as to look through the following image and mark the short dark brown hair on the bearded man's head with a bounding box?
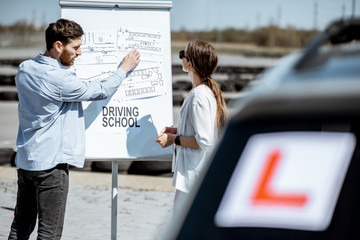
[45,19,84,50]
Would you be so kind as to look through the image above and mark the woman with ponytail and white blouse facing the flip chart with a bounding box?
[156,40,226,216]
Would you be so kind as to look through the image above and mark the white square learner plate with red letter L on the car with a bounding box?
[215,132,356,231]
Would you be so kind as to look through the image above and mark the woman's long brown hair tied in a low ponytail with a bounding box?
[185,40,226,129]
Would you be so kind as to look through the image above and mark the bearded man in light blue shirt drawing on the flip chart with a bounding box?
[9,19,140,240]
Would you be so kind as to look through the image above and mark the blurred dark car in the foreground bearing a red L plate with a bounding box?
[162,18,360,240]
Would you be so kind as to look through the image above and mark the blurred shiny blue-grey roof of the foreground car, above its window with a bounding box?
[230,42,360,121]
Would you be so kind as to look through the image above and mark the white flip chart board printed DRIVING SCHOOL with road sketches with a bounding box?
[60,0,173,160]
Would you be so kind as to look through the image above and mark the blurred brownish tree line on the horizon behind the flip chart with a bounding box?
[0,20,319,48]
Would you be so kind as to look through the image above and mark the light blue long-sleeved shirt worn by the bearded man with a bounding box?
[15,55,126,171]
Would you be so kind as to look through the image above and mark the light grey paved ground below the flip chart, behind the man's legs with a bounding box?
[0,166,174,240]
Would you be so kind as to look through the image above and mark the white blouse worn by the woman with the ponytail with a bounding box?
[172,84,217,192]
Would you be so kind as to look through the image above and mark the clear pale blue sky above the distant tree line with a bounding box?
[0,0,360,31]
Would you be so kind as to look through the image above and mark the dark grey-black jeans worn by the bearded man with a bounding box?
[9,164,69,240]
